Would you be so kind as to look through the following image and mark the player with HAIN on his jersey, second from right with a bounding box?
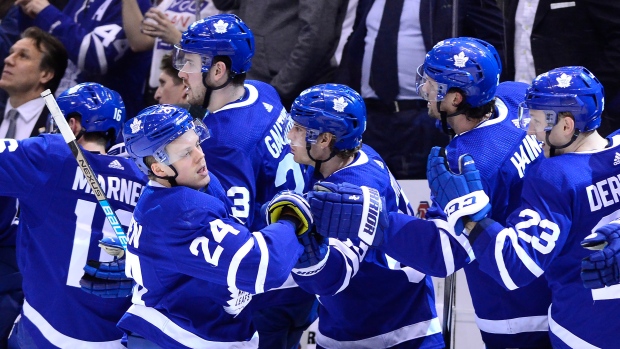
[310,38,551,348]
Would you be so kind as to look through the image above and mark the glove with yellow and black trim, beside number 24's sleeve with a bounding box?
[265,190,314,235]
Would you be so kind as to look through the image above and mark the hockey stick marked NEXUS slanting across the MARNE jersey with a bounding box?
[41,90,127,250]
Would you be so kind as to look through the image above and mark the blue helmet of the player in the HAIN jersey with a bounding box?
[416,37,502,107]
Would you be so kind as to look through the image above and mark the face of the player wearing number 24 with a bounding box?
[166,130,211,189]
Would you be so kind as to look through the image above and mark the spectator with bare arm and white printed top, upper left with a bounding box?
[122,0,220,104]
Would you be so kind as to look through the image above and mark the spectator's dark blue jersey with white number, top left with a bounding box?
[19,0,152,118]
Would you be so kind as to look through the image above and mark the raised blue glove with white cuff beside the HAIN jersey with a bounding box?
[426,147,491,234]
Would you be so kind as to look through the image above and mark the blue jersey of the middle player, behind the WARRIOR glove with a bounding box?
[293,145,444,349]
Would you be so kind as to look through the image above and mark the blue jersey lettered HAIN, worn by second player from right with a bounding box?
[381,82,551,348]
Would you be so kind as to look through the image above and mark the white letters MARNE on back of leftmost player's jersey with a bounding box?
[71,167,143,207]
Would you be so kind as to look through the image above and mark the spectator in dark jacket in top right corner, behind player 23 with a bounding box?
[499,0,620,137]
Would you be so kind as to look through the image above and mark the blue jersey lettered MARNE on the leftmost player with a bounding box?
[0,135,146,348]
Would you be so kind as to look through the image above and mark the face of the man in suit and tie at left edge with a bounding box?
[0,38,53,94]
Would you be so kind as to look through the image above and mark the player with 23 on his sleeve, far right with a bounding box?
[439,67,620,348]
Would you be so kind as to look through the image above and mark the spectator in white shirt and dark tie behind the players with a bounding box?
[337,0,503,179]
